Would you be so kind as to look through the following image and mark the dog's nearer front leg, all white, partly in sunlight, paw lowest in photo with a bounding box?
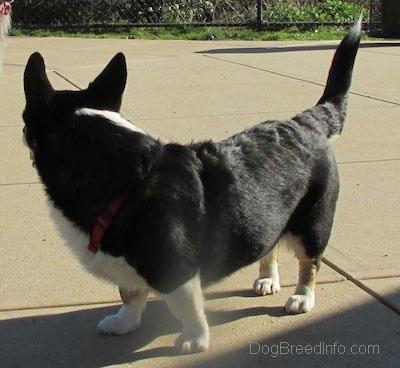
[163,273,209,354]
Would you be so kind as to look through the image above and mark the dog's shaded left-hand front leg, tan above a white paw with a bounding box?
[98,288,149,335]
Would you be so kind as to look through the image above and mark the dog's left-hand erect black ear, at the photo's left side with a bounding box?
[24,52,54,106]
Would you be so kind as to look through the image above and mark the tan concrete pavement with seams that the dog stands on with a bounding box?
[0,38,400,368]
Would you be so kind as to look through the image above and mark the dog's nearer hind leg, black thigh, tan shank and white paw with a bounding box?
[285,151,339,313]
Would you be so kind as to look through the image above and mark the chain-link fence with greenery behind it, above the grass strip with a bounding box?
[13,0,381,29]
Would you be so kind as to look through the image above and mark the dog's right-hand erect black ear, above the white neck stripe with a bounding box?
[87,52,127,111]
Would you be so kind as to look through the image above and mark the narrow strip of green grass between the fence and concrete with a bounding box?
[11,26,368,41]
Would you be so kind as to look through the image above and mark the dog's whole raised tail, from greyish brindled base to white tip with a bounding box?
[299,17,362,138]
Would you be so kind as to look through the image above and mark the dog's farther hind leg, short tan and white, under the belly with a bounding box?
[253,242,281,295]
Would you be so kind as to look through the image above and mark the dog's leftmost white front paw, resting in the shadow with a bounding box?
[97,306,140,335]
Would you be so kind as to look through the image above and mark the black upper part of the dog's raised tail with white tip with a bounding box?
[317,17,362,105]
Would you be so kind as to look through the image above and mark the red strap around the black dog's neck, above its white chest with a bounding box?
[88,194,126,254]
